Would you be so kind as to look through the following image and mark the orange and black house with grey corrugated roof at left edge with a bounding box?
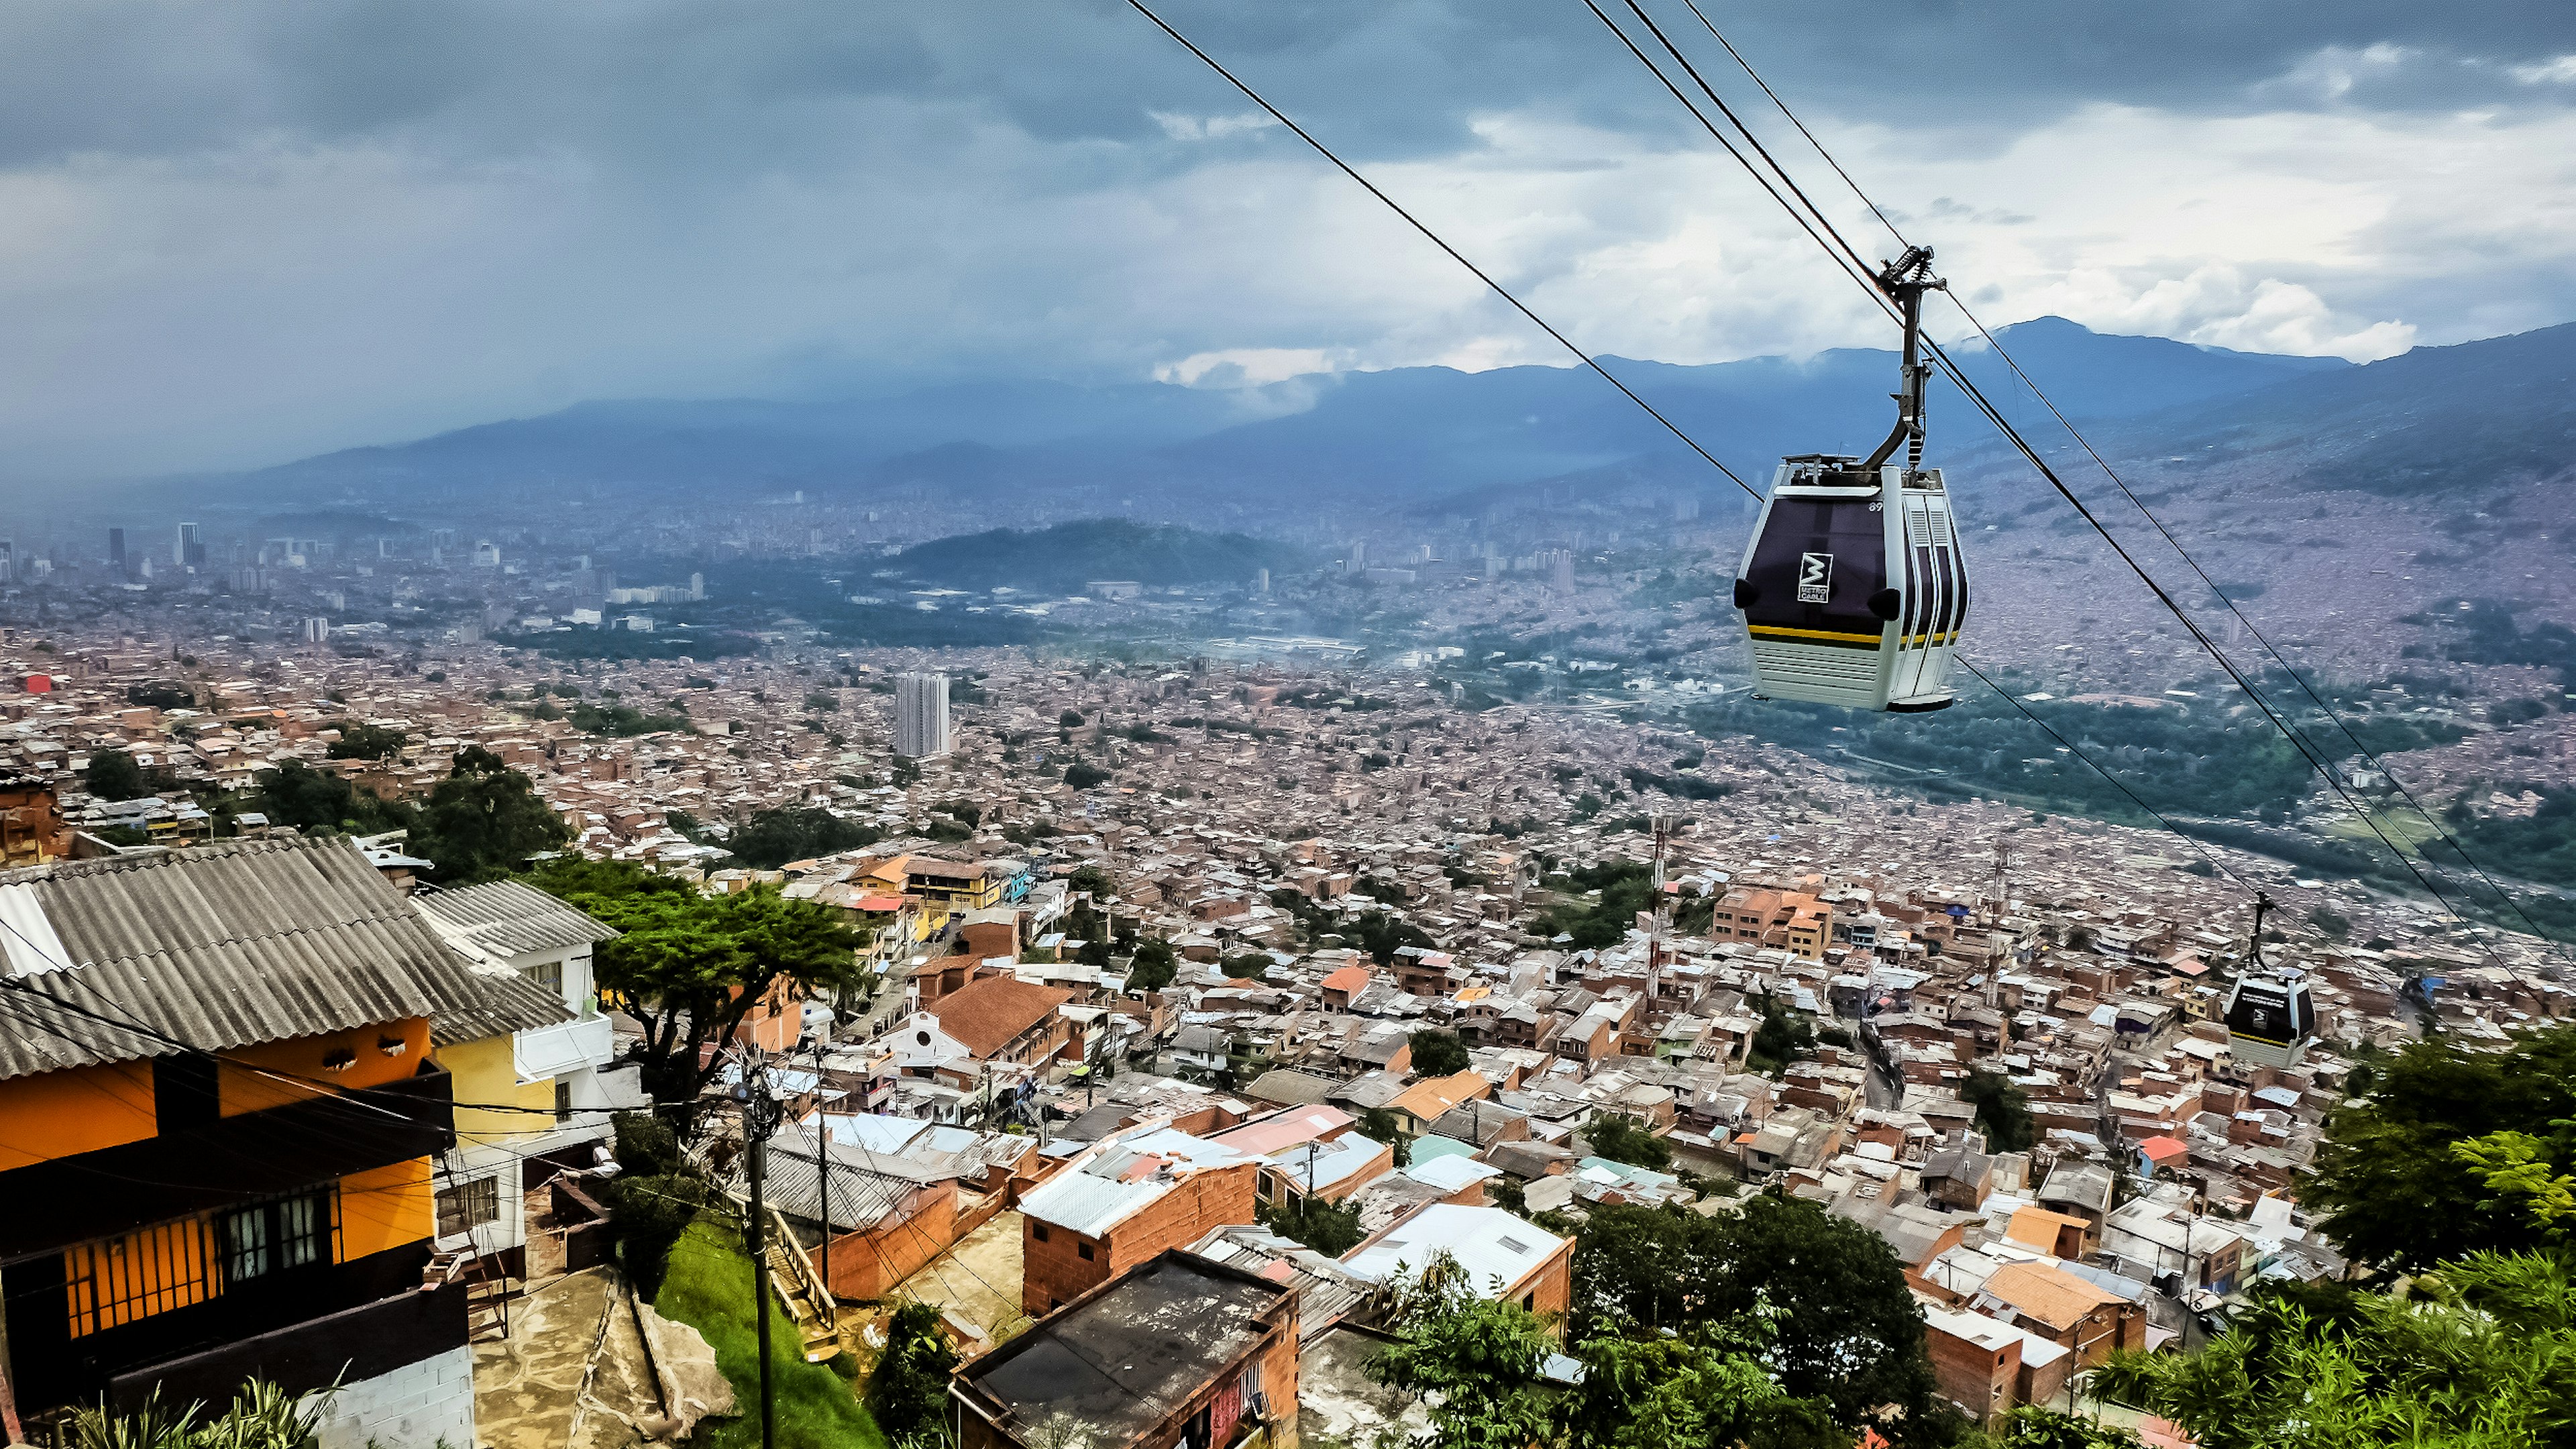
[0,838,523,1446]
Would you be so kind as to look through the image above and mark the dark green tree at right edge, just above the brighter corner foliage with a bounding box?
[2300,1024,2576,1271]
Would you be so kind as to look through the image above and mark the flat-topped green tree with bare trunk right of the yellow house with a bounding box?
[531,861,865,1109]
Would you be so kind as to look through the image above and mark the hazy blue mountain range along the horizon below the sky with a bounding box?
[100,317,2576,526]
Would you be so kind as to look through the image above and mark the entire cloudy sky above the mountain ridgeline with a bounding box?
[0,0,2576,480]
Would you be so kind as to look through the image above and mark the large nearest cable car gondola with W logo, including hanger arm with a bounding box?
[1736,248,1968,714]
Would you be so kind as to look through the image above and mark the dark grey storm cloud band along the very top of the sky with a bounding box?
[20,0,2576,162]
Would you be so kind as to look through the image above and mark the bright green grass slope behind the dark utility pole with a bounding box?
[652,1217,886,1449]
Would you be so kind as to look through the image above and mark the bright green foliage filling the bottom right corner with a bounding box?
[2094,1253,2576,1449]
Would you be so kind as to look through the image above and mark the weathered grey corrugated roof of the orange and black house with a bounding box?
[0,838,513,1080]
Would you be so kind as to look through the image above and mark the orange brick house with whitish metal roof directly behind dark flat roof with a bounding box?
[1020,1122,1263,1315]
